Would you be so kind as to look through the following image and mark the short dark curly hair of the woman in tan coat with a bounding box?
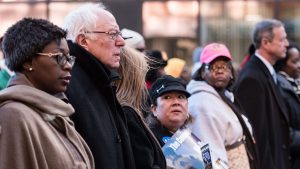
[2,18,67,72]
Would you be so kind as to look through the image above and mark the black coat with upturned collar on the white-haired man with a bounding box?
[66,41,135,169]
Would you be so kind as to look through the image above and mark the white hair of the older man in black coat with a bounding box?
[62,3,107,42]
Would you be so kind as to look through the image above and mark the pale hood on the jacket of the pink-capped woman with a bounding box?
[186,80,234,102]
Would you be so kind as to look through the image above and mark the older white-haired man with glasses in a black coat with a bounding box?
[64,4,135,169]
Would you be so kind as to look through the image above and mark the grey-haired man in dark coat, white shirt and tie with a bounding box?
[235,19,289,169]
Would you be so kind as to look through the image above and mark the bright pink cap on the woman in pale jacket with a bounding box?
[200,43,232,63]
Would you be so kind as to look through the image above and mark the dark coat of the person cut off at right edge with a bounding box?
[277,74,300,169]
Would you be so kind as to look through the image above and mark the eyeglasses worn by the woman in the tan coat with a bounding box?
[37,52,75,66]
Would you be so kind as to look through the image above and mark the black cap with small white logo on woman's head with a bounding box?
[149,75,191,103]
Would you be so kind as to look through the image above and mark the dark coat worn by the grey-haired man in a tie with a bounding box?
[235,56,290,169]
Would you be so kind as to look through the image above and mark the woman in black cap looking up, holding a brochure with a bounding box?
[148,75,190,146]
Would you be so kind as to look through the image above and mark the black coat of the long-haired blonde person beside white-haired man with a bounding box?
[123,106,166,169]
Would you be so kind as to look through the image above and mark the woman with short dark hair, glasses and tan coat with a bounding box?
[0,18,94,169]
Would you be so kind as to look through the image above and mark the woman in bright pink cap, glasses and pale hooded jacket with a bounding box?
[187,43,257,169]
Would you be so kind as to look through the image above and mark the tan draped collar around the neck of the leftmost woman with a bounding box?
[0,73,74,117]
